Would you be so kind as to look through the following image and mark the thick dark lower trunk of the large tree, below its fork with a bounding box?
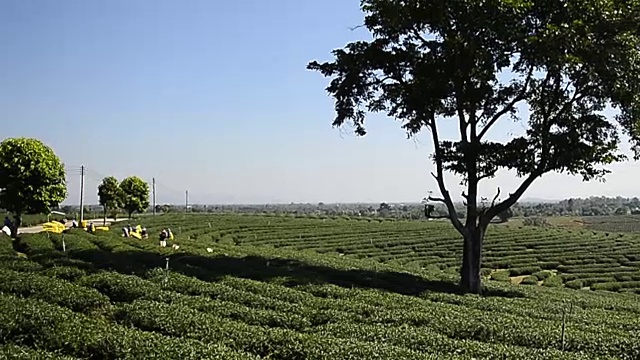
[460,225,486,294]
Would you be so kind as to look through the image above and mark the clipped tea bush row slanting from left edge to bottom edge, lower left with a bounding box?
[0,294,256,360]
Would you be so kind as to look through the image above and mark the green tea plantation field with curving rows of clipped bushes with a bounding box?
[0,215,640,359]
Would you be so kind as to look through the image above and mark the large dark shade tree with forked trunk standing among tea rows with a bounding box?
[307,0,640,293]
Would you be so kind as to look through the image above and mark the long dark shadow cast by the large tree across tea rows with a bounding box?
[28,249,524,298]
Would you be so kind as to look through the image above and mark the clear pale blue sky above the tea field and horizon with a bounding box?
[0,0,640,203]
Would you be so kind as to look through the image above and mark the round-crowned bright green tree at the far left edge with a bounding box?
[0,138,67,237]
